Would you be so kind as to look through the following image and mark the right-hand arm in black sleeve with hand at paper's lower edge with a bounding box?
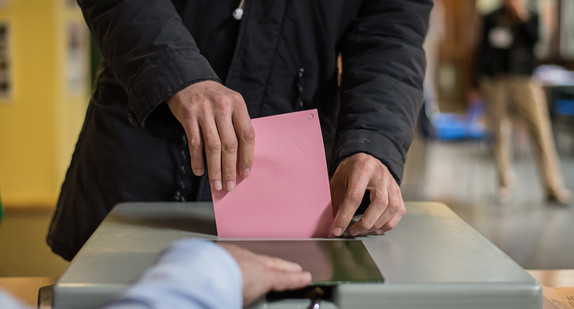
[331,0,432,235]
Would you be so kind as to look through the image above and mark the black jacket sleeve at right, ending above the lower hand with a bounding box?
[333,0,432,183]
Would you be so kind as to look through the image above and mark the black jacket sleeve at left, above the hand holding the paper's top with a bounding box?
[78,0,219,135]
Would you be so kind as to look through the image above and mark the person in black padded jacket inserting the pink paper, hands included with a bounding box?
[48,0,432,259]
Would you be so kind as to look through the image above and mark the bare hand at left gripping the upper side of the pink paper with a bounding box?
[167,81,255,191]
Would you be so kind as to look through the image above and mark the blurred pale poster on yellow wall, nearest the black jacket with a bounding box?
[66,22,88,96]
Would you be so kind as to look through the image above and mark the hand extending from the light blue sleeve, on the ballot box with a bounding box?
[219,242,311,305]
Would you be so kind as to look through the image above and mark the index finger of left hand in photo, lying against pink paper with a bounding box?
[233,100,255,178]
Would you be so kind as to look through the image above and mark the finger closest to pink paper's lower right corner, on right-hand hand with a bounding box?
[333,172,368,236]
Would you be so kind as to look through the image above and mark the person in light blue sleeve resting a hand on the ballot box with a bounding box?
[0,239,311,309]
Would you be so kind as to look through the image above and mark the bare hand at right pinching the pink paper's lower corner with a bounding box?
[330,153,405,236]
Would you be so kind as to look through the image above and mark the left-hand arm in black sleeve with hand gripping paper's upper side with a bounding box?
[79,0,255,191]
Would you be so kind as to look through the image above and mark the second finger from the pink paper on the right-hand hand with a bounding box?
[349,185,391,236]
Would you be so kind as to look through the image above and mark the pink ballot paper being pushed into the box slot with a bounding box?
[211,110,333,238]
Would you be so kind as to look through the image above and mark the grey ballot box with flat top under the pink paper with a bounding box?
[53,202,542,309]
